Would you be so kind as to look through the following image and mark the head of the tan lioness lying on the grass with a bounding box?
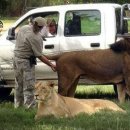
[34,81,54,101]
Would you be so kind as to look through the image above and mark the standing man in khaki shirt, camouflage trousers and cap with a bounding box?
[14,17,56,108]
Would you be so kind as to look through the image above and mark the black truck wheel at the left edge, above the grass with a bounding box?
[0,87,12,100]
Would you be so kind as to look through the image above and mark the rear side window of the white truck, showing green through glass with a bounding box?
[64,10,101,36]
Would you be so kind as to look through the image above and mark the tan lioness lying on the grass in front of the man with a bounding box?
[35,81,125,119]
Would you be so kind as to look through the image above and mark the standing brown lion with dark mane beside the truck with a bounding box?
[47,38,130,103]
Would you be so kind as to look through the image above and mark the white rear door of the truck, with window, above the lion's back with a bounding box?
[60,9,105,51]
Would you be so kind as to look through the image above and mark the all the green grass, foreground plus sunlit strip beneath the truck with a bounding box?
[0,86,130,130]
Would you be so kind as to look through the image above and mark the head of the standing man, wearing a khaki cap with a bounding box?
[33,17,46,32]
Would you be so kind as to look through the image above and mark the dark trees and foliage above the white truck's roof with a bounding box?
[0,0,128,17]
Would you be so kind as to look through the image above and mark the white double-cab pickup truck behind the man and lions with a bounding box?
[0,4,130,97]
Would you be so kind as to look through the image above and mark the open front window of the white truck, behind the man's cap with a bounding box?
[15,12,59,37]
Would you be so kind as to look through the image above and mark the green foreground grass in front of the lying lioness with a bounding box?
[0,103,130,130]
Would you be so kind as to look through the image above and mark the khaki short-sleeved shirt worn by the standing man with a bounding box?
[14,25,43,58]
